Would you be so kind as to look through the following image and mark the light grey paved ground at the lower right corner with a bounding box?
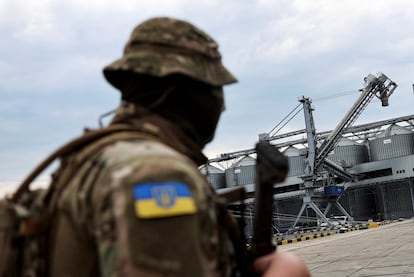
[278,219,414,277]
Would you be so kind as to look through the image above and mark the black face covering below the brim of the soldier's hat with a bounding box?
[118,72,224,148]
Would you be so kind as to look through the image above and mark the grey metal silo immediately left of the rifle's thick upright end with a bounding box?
[225,156,256,187]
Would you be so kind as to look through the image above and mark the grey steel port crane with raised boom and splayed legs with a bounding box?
[262,73,397,227]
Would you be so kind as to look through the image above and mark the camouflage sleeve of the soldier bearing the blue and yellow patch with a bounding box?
[94,142,228,276]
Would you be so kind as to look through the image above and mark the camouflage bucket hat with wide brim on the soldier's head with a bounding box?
[104,17,237,88]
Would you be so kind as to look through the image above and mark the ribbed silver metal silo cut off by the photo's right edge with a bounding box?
[369,125,414,161]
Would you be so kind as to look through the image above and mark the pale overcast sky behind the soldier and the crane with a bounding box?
[0,0,414,191]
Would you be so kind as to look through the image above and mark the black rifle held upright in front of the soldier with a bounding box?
[220,141,288,277]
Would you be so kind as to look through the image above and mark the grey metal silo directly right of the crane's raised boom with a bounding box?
[328,140,369,167]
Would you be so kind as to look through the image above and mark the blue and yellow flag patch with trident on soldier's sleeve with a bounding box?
[133,182,197,218]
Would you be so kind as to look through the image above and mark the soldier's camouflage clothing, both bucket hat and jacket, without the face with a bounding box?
[48,18,236,276]
